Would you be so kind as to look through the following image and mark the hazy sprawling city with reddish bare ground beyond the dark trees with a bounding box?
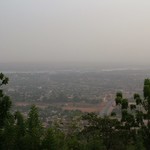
[2,69,150,126]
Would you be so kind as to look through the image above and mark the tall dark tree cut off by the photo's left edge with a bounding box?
[0,73,15,150]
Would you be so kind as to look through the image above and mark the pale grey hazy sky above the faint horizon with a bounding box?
[0,0,150,63]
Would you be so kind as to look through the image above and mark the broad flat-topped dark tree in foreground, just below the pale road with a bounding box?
[82,113,124,150]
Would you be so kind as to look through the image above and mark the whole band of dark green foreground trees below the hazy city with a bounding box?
[0,73,150,150]
